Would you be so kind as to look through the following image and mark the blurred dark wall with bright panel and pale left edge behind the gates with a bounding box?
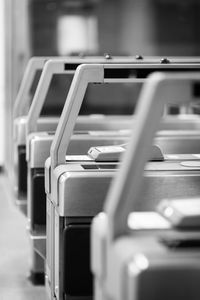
[0,0,200,172]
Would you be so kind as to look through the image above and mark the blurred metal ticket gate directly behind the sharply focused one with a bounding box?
[27,59,199,262]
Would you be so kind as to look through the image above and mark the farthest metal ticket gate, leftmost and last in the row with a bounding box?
[14,57,199,207]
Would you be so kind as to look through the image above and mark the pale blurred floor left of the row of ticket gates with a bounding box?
[0,175,46,300]
